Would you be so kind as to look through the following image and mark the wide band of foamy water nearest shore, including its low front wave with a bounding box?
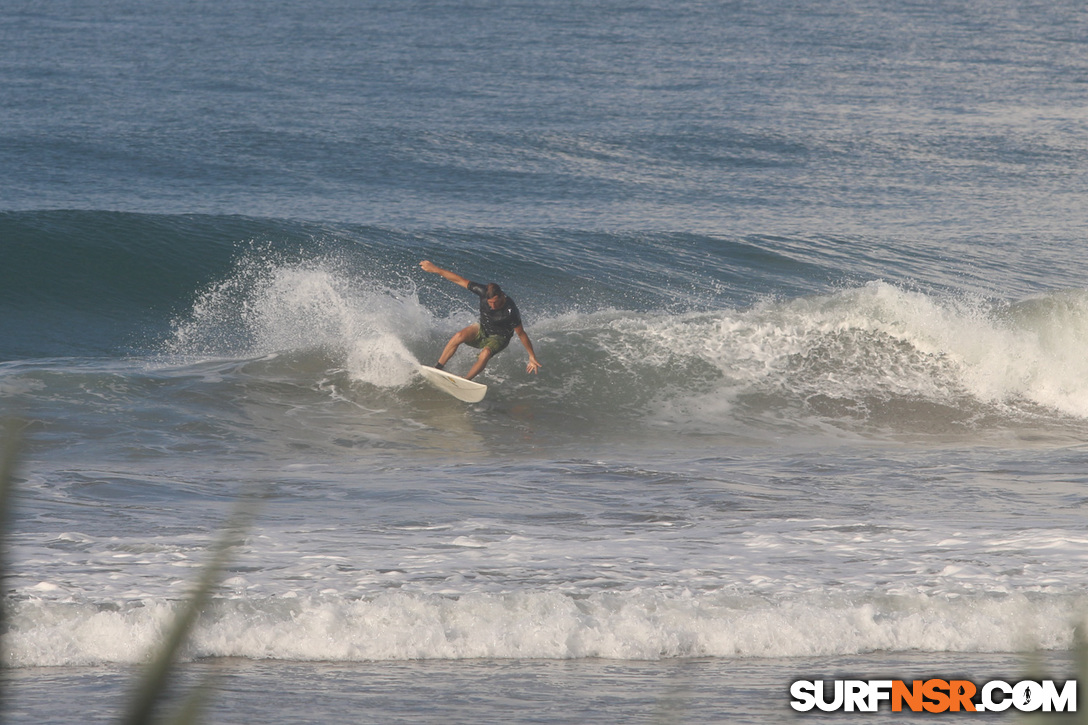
[12,500,1088,666]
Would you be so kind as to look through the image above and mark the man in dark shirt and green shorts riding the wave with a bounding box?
[419,259,541,380]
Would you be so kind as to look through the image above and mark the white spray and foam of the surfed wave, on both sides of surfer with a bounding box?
[158,251,1088,431]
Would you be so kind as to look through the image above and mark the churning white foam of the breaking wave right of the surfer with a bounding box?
[603,282,1088,430]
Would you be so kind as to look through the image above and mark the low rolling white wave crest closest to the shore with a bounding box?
[8,590,1088,667]
